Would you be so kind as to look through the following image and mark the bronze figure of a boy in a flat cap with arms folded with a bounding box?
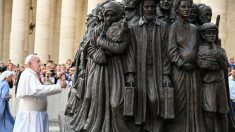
[198,23,229,132]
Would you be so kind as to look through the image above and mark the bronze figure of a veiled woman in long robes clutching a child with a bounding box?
[67,1,134,132]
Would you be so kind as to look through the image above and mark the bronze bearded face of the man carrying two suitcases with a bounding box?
[143,1,156,20]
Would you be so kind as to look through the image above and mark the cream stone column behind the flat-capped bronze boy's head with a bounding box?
[201,0,228,47]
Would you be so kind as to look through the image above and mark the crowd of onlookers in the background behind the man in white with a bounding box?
[0,59,75,87]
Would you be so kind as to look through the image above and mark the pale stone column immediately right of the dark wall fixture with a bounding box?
[34,0,51,63]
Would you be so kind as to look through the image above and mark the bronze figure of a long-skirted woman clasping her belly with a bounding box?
[166,0,204,132]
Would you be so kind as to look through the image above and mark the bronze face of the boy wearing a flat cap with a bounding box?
[203,29,217,43]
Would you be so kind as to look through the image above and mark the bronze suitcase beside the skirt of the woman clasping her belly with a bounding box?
[160,86,175,119]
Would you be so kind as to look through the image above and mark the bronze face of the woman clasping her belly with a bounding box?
[178,1,192,18]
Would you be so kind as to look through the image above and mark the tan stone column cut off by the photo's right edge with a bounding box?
[225,0,235,58]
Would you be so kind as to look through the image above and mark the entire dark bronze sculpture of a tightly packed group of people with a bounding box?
[65,0,235,132]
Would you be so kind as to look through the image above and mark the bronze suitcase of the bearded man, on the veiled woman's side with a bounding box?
[123,85,135,116]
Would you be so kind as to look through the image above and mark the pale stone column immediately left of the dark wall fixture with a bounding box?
[10,0,27,64]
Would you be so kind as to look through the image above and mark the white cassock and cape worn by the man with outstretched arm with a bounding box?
[13,68,61,132]
